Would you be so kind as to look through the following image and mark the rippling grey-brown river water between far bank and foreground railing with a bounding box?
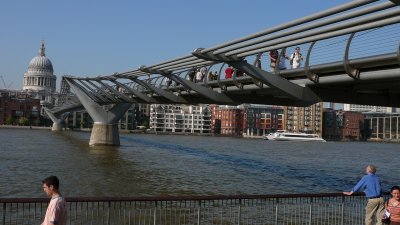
[0,129,400,198]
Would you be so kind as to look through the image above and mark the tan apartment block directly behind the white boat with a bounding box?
[285,102,323,136]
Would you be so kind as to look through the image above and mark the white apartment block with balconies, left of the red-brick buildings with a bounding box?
[150,104,211,133]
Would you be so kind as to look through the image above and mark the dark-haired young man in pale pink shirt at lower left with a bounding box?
[42,176,67,225]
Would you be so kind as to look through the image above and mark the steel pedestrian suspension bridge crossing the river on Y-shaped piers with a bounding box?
[47,0,400,145]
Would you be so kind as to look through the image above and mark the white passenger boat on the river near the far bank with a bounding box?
[264,130,326,142]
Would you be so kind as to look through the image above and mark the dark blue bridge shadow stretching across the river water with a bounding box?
[123,136,353,191]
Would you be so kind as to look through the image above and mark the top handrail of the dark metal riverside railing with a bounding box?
[0,192,390,203]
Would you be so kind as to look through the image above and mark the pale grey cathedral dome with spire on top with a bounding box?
[27,42,54,75]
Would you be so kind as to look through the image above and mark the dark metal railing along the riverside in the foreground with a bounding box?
[0,193,388,225]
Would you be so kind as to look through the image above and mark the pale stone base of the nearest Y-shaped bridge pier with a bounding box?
[89,123,120,145]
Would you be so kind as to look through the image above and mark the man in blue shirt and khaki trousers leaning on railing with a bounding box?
[343,165,385,225]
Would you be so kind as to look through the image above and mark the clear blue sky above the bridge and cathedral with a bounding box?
[0,0,350,89]
